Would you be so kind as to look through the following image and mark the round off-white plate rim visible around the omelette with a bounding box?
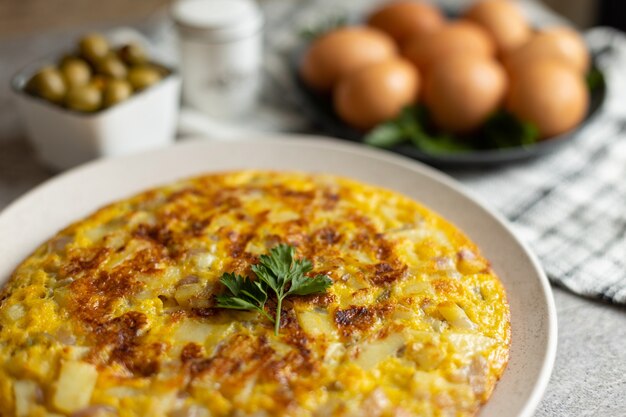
[0,137,556,417]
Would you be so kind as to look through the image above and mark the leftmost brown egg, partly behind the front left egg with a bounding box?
[300,26,397,91]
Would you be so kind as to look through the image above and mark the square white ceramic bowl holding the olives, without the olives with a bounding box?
[11,57,180,170]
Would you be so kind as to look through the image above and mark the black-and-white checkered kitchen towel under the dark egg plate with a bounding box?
[258,0,626,304]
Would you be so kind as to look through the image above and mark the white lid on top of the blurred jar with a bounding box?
[171,0,263,42]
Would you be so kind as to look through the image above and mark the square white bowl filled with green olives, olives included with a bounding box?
[12,33,180,170]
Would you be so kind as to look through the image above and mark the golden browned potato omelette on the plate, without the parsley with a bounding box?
[0,171,510,417]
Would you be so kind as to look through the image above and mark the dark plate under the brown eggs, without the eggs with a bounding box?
[290,50,607,166]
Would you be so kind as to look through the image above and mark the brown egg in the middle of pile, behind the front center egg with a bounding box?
[402,20,495,73]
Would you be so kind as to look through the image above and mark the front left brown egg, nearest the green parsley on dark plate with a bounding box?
[333,58,420,130]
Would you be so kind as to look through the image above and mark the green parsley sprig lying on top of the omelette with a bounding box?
[217,244,333,335]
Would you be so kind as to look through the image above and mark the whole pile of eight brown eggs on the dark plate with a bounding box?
[300,0,590,139]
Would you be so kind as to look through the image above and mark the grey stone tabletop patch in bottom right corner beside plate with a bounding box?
[536,288,626,417]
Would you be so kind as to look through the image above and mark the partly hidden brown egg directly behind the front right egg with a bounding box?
[504,27,590,74]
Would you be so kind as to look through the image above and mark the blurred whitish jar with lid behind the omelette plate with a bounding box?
[172,0,263,119]
